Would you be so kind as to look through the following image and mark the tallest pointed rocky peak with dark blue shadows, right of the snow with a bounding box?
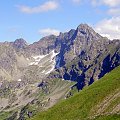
[48,24,120,89]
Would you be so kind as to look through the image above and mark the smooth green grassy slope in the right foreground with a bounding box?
[32,66,120,120]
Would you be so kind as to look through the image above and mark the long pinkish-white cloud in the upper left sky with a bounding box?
[17,1,59,14]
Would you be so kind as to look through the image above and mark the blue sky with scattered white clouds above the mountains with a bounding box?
[0,0,120,43]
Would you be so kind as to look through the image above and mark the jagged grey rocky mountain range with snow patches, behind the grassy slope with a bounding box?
[0,24,120,119]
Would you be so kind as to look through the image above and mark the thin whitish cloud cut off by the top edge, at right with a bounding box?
[91,0,120,7]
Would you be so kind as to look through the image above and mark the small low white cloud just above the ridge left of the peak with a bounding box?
[38,28,60,36]
